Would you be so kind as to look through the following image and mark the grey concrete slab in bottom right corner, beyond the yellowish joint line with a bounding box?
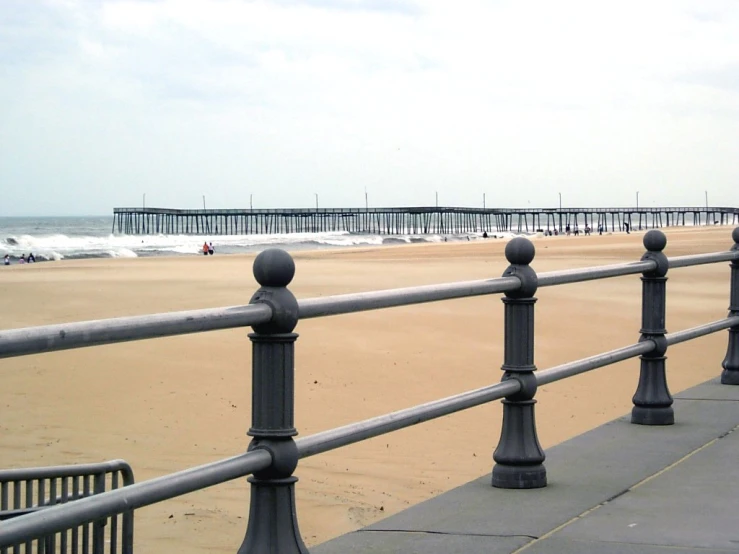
[554,422,739,552]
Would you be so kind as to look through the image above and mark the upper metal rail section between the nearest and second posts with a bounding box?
[298,277,521,319]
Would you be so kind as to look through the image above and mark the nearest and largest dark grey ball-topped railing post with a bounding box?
[239,248,308,554]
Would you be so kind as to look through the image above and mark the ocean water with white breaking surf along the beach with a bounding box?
[0,216,514,263]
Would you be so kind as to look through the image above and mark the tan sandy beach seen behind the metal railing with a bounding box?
[0,227,732,554]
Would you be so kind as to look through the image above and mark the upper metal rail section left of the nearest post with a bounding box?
[0,304,272,358]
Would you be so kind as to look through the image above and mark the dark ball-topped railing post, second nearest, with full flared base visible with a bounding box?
[493,237,547,489]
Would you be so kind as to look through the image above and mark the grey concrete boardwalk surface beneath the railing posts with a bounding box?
[311,380,739,554]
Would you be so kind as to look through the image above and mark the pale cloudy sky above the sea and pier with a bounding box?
[0,0,739,215]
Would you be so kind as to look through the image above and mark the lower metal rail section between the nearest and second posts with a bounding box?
[295,380,521,458]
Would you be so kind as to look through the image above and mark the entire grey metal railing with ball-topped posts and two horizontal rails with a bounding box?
[0,228,739,554]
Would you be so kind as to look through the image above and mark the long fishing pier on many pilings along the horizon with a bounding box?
[112,207,739,235]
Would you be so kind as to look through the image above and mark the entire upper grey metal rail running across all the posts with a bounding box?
[0,251,739,358]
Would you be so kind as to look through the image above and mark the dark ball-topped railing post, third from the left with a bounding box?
[631,229,675,425]
